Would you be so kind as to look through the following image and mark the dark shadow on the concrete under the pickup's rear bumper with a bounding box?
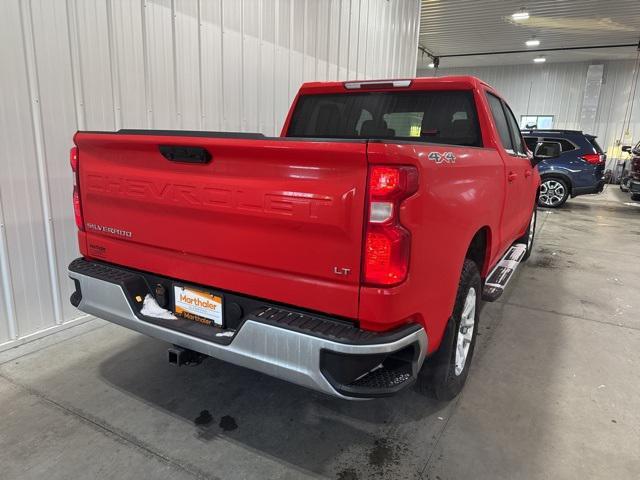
[100,337,447,479]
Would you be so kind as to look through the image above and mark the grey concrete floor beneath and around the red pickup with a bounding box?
[0,187,640,480]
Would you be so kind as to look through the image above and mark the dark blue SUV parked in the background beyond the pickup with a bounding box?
[522,130,607,208]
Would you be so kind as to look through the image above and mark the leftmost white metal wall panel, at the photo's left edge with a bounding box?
[0,0,55,342]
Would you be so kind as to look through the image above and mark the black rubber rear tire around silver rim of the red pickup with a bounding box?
[417,259,482,401]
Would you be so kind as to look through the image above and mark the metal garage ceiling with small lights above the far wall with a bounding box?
[418,0,640,68]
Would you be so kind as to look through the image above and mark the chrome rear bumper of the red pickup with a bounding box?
[69,264,427,399]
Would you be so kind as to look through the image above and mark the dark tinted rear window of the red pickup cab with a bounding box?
[287,90,482,147]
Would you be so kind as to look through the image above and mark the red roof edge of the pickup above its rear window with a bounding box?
[300,75,493,94]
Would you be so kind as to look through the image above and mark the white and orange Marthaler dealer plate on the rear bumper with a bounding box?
[173,285,224,327]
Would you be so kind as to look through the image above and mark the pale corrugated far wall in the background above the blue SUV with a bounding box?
[418,61,640,158]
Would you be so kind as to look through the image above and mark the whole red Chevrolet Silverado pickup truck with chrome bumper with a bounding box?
[69,77,557,399]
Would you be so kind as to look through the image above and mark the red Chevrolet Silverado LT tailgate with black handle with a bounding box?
[75,132,367,318]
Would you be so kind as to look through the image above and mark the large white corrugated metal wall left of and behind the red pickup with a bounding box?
[0,0,420,349]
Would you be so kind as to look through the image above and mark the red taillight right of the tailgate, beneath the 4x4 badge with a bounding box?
[362,165,418,287]
